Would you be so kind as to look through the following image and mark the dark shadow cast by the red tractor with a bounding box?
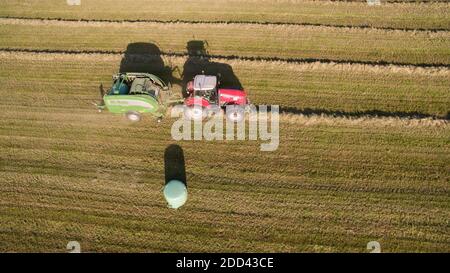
[181,40,243,97]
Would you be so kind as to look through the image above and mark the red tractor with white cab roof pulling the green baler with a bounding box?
[184,75,249,122]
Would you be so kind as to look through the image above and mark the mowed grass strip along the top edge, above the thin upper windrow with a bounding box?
[0,0,450,29]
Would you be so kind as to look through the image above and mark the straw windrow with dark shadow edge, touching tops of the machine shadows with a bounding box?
[0,47,450,69]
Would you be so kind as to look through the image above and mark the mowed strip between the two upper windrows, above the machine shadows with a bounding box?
[0,19,450,65]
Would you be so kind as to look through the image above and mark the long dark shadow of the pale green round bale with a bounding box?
[164,144,187,188]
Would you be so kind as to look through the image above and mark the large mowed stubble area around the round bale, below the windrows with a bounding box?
[0,56,450,252]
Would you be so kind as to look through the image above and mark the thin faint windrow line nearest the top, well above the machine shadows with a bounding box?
[0,16,450,33]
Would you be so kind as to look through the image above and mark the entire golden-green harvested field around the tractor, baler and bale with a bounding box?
[0,0,450,252]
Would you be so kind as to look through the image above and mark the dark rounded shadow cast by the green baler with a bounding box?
[119,42,174,83]
